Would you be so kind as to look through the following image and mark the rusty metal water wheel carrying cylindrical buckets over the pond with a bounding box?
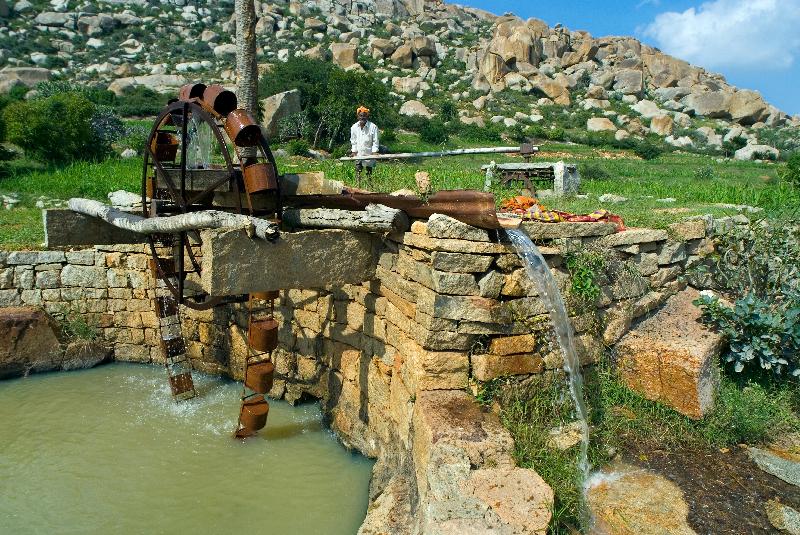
[142,84,281,310]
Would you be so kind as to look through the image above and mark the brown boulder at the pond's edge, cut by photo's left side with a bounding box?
[0,307,63,379]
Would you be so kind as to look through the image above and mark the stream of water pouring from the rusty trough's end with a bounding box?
[506,229,589,491]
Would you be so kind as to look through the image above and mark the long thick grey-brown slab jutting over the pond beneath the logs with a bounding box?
[201,229,380,295]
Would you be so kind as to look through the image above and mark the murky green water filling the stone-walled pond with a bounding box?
[0,364,372,535]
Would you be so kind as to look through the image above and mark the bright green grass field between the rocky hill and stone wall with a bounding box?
[0,133,800,249]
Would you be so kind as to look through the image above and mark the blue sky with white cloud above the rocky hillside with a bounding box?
[456,0,800,114]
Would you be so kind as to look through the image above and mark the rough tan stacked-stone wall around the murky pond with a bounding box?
[0,215,710,533]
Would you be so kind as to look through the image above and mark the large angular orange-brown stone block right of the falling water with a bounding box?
[617,289,722,418]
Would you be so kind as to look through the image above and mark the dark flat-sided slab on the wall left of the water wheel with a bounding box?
[42,209,146,247]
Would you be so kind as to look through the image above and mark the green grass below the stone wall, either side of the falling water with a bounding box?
[496,361,800,534]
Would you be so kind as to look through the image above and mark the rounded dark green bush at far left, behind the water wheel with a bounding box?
[3,93,108,163]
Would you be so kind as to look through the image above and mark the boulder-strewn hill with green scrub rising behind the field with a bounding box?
[0,0,800,156]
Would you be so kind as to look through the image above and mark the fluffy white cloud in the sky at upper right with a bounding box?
[639,0,800,71]
